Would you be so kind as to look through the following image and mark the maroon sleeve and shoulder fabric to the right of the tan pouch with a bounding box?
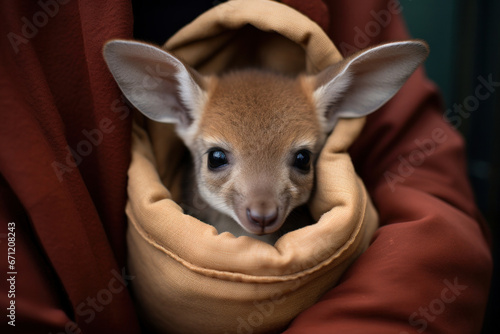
[286,0,492,334]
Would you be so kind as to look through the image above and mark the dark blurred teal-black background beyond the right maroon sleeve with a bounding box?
[400,0,500,334]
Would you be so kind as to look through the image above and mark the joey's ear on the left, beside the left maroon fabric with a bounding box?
[103,40,206,128]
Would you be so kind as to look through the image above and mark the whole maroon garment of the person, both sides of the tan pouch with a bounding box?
[0,0,492,334]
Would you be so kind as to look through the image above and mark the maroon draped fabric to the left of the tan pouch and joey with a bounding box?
[0,0,139,333]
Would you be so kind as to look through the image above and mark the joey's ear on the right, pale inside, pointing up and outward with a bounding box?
[314,40,429,131]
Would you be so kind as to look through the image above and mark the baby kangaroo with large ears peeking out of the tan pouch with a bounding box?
[104,40,428,243]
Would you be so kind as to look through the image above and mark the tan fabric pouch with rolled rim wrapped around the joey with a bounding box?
[127,0,378,333]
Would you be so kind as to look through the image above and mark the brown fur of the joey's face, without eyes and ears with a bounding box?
[180,70,326,240]
